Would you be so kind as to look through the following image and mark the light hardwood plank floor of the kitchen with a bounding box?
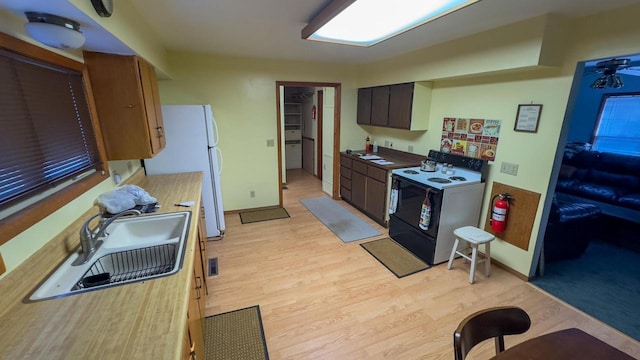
[206,170,640,360]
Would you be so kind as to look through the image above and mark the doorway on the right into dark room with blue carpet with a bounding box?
[531,55,640,340]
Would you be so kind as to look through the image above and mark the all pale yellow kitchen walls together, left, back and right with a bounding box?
[0,0,640,274]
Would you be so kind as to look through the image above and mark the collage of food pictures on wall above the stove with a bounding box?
[440,118,502,161]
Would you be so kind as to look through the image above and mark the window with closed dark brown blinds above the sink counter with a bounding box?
[0,50,101,210]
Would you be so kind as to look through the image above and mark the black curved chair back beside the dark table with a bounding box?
[453,306,531,360]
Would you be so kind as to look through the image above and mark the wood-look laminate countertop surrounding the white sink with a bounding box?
[0,169,202,360]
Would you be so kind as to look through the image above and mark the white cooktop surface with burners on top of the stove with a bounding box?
[391,166,482,190]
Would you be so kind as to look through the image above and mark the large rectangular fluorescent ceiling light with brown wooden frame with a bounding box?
[302,0,480,46]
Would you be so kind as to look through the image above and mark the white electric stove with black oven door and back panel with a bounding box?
[389,150,487,265]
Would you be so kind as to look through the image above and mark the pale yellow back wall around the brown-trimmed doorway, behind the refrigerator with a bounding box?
[160,52,364,211]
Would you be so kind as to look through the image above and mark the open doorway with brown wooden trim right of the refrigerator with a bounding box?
[276,81,341,206]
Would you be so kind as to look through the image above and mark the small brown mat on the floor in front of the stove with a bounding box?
[360,238,431,278]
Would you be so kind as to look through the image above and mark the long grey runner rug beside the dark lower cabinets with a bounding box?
[300,196,382,243]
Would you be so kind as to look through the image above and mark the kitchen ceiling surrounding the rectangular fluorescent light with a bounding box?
[0,0,639,64]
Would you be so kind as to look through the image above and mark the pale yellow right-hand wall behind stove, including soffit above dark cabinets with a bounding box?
[359,6,640,275]
